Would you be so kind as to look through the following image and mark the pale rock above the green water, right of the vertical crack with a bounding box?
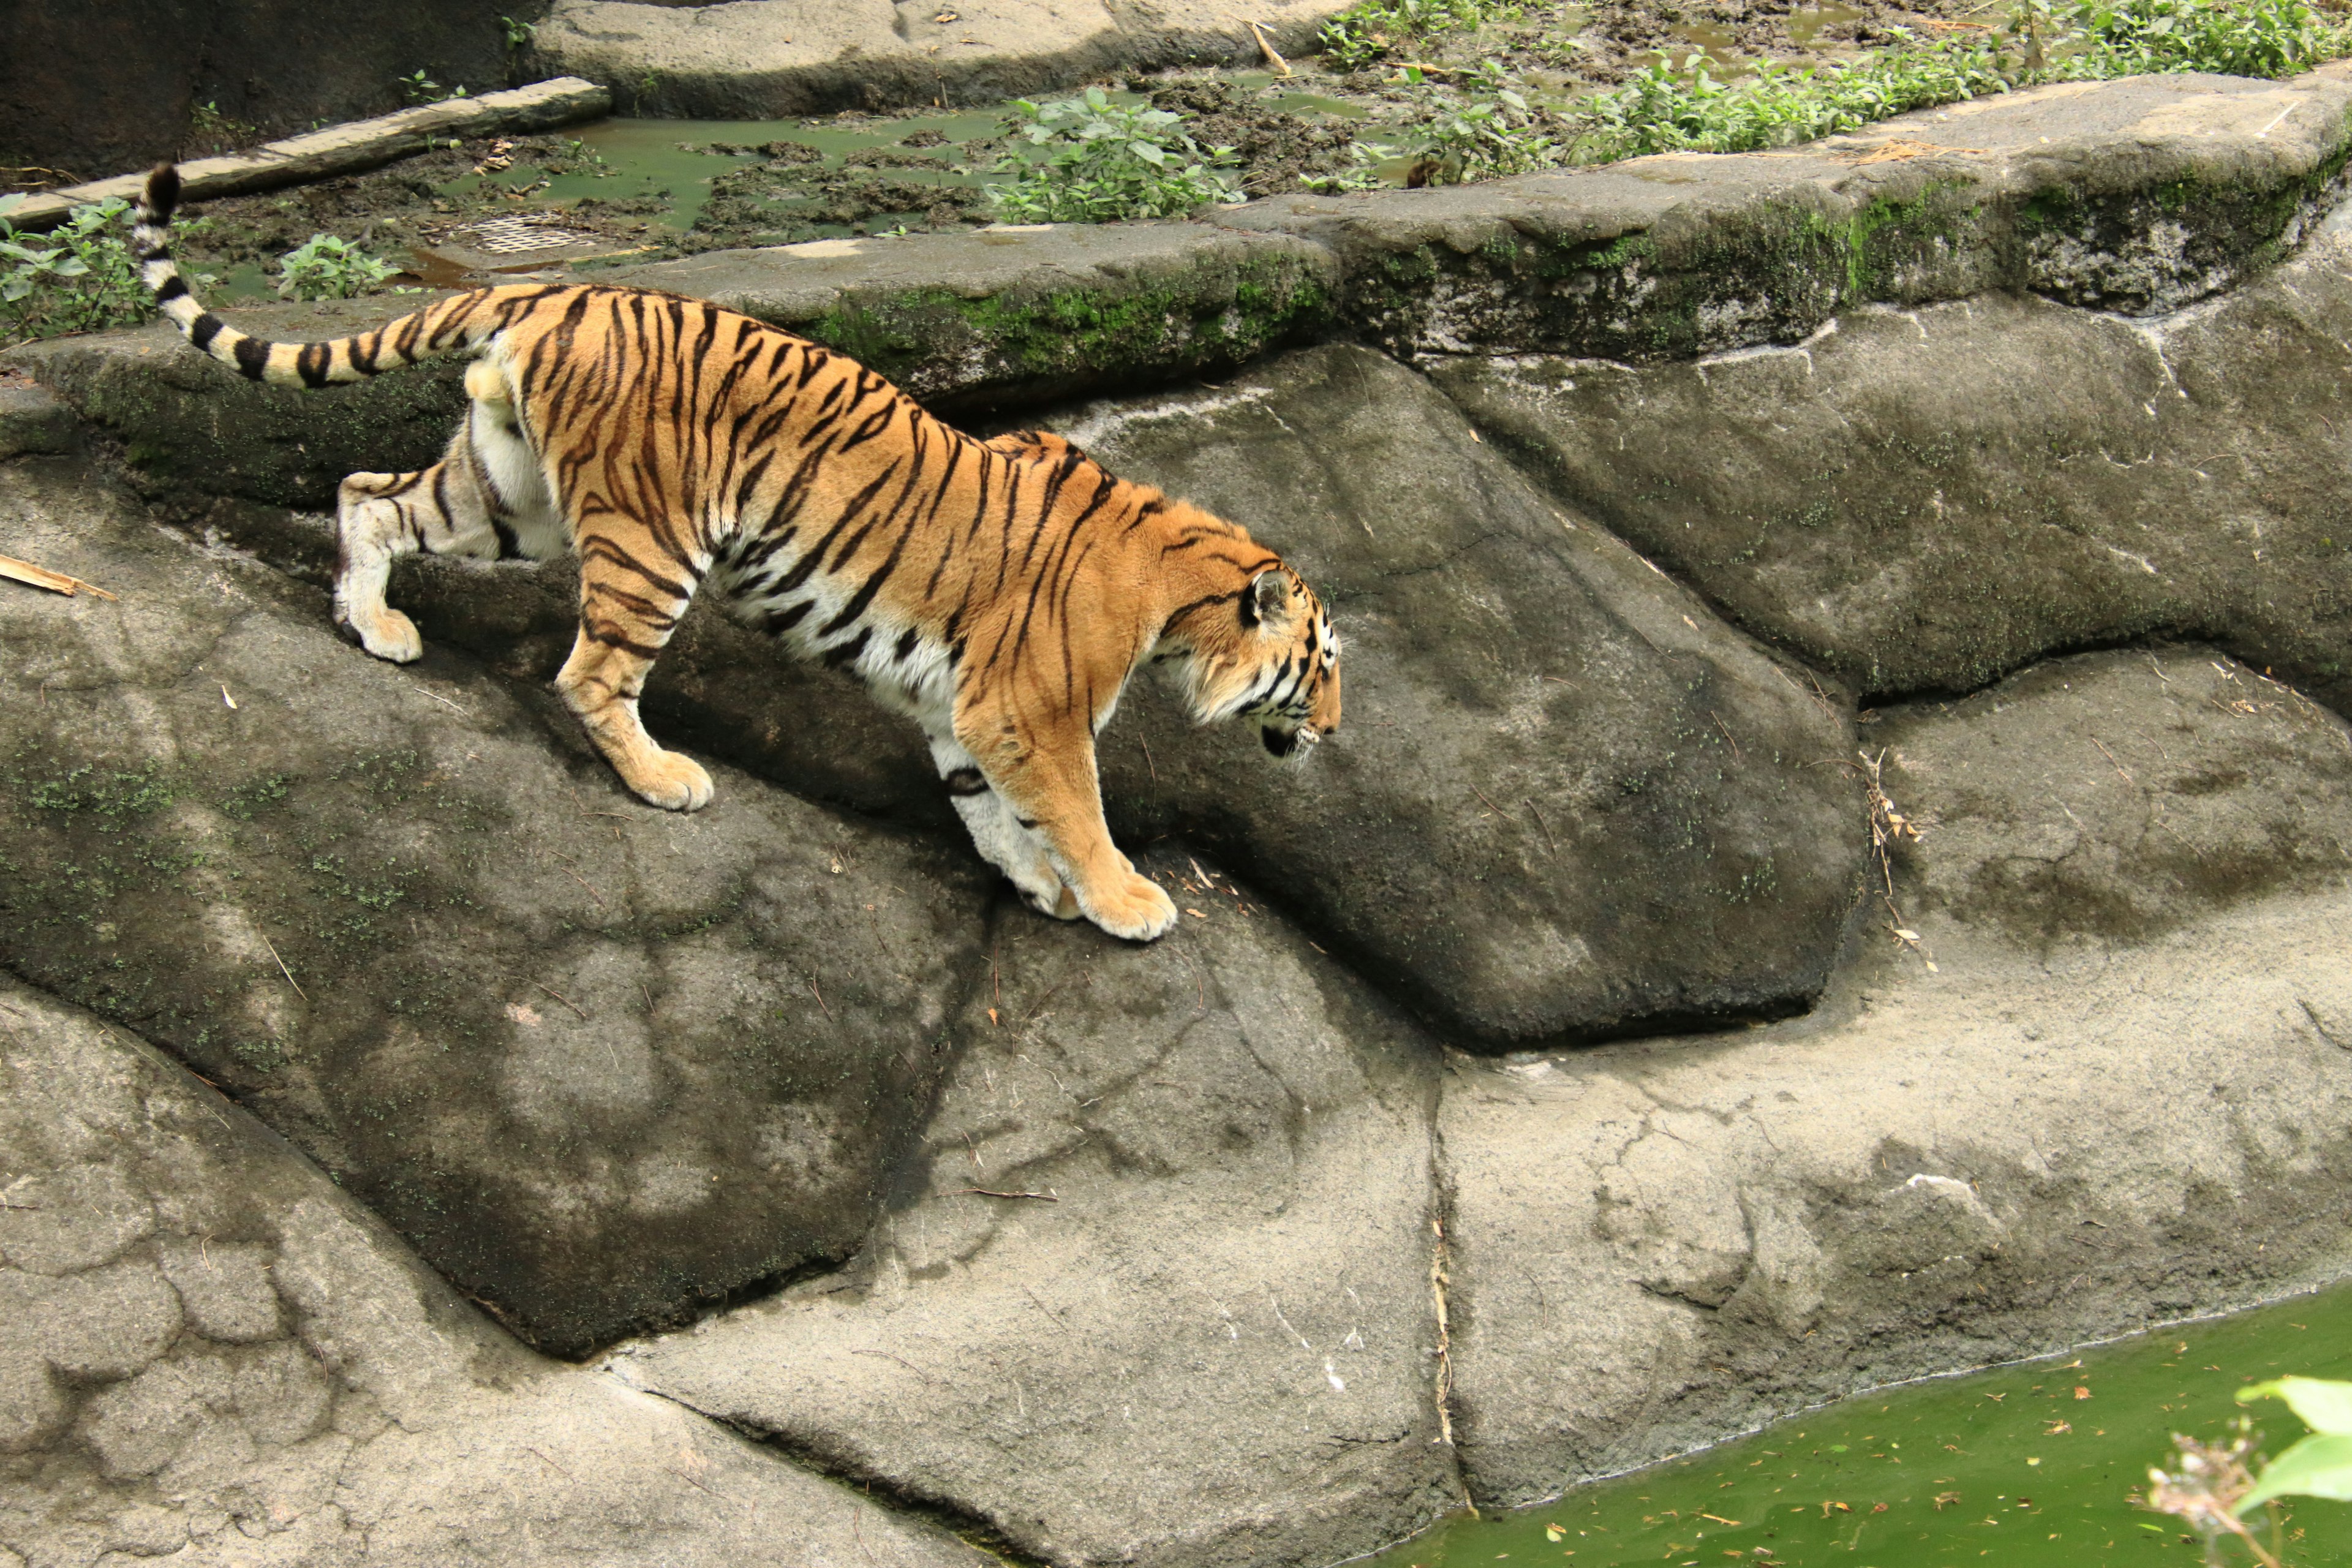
[1437,651,2352,1502]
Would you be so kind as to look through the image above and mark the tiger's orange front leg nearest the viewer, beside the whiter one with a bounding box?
[957,710,1176,943]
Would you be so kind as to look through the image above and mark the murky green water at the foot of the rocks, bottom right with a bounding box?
[1366,1286,2352,1568]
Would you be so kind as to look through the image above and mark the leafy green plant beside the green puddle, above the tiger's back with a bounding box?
[988,87,1242,224]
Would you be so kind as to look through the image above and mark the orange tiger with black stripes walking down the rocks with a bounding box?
[132,165,1341,940]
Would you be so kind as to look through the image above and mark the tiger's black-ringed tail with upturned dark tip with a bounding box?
[132,162,506,385]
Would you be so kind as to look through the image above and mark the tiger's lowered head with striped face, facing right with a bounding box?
[1188,564,1338,757]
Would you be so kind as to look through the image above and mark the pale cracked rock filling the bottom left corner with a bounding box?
[0,980,992,1568]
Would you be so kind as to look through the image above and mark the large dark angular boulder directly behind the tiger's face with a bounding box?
[1061,345,1865,1046]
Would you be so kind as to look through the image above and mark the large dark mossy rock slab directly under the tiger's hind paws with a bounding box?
[0,447,988,1354]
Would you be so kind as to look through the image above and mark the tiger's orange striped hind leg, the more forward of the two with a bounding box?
[555,529,710,811]
